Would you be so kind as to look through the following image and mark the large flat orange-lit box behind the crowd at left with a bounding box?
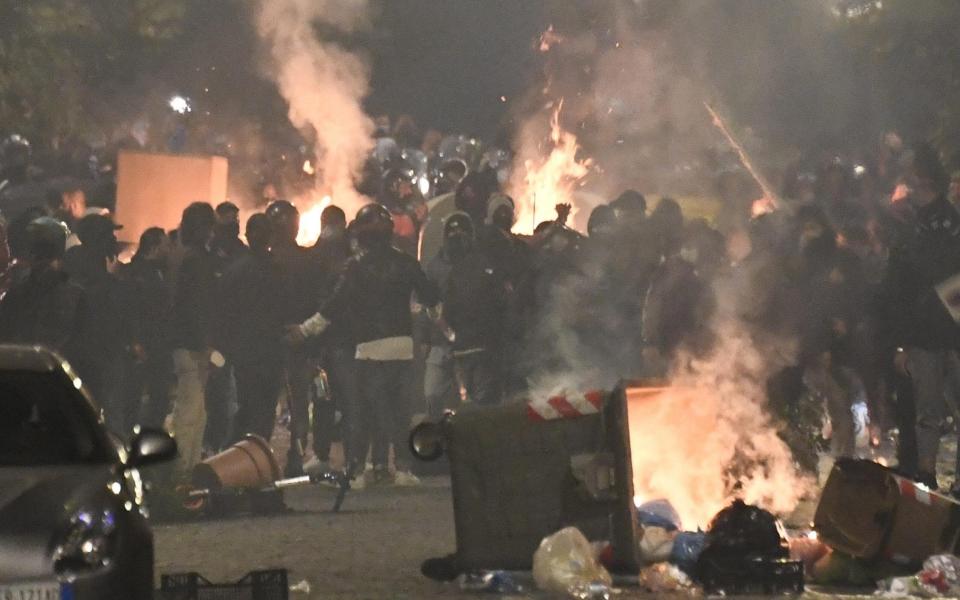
[115,151,228,243]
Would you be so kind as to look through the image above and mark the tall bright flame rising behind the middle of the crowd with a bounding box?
[510,100,593,234]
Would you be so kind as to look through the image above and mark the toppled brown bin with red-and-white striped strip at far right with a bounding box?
[814,459,960,565]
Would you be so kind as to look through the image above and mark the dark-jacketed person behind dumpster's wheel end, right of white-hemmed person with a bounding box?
[442,213,507,406]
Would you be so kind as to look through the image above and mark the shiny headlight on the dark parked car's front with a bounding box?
[53,510,117,574]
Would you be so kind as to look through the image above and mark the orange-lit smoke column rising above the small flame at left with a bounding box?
[256,0,374,212]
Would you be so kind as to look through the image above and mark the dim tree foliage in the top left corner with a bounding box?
[0,0,187,140]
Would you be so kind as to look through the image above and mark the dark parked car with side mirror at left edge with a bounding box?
[0,346,177,600]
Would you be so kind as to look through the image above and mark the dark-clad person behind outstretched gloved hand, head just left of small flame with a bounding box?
[266,200,320,477]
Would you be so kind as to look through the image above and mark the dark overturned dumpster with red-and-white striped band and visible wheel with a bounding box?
[411,386,639,573]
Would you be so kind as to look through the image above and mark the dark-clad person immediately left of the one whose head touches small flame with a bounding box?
[220,213,283,441]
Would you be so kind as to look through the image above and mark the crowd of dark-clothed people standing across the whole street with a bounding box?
[0,124,960,489]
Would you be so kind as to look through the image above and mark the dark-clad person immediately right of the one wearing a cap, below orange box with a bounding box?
[120,227,173,427]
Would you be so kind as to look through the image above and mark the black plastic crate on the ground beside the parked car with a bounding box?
[159,569,290,600]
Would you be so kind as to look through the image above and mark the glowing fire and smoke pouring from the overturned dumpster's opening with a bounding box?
[628,280,813,528]
